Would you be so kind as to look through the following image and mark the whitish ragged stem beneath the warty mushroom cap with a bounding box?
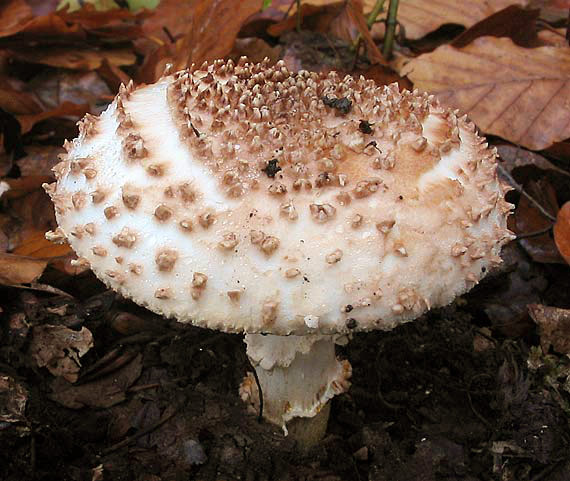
[240,334,351,437]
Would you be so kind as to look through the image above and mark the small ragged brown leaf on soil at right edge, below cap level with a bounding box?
[528,304,570,354]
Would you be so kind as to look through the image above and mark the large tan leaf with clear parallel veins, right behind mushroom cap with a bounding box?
[400,37,570,150]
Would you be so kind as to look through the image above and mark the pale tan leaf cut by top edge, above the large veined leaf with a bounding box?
[365,0,528,40]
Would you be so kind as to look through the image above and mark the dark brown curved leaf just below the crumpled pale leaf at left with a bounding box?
[49,354,143,409]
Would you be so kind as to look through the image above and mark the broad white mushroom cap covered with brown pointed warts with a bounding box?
[46,59,512,335]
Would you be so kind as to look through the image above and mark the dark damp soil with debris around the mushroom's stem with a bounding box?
[0,249,570,481]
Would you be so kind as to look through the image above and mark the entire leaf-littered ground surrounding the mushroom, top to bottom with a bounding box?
[0,0,570,481]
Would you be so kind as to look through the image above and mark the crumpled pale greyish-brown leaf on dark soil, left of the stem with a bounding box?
[30,324,93,382]
